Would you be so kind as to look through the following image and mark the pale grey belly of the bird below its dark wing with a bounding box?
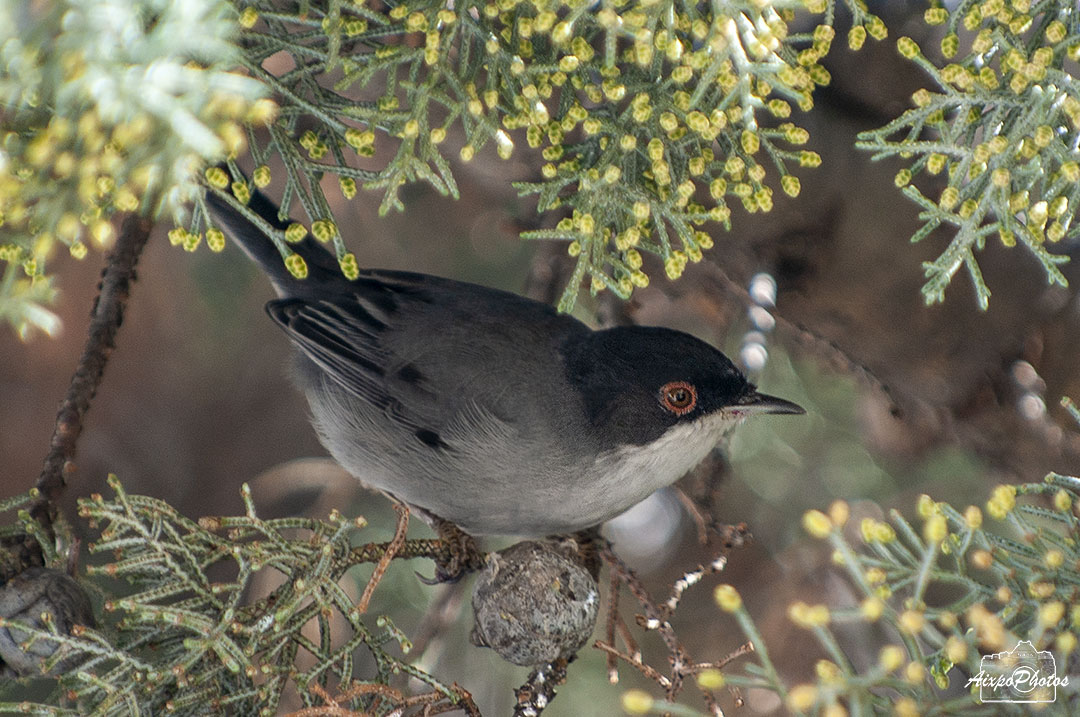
[308,387,679,537]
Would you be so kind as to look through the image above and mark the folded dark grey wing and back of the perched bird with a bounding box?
[267,270,589,443]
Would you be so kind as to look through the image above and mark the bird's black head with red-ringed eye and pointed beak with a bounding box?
[567,326,805,446]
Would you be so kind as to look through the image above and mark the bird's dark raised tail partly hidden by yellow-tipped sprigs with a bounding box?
[206,184,348,297]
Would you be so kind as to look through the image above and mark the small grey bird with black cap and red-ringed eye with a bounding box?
[206,184,805,544]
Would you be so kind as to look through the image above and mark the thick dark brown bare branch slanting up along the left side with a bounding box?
[30,210,153,532]
